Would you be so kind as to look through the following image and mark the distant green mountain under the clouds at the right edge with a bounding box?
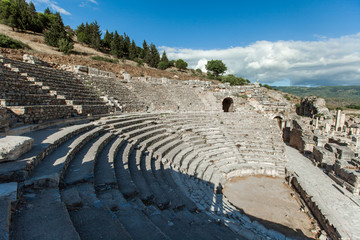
[276,86,360,106]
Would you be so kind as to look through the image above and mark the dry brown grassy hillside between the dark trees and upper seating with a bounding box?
[0,24,205,80]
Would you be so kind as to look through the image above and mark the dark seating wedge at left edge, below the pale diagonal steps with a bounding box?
[0,58,74,123]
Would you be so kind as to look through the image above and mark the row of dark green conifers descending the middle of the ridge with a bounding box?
[75,21,188,70]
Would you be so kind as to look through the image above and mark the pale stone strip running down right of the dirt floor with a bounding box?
[286,147,360,239]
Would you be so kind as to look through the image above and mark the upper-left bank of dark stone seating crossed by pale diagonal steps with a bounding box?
[0,58,111,124]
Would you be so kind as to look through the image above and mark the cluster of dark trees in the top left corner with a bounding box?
[0,0,73,53]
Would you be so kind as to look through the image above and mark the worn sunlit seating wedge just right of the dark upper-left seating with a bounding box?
[78,75,146,112]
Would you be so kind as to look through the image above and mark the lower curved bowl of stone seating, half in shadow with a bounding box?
[0,113,285,239]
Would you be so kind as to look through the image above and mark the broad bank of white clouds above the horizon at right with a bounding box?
[160,33,360,86]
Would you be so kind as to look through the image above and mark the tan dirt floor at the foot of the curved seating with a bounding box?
[224,176,316,239]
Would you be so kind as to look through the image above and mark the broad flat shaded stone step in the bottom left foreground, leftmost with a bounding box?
[11,189,80,240]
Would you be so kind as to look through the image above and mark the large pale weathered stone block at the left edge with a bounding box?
[0,136,34,162]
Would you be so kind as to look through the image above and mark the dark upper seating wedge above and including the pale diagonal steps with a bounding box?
[3,58,110,118]
